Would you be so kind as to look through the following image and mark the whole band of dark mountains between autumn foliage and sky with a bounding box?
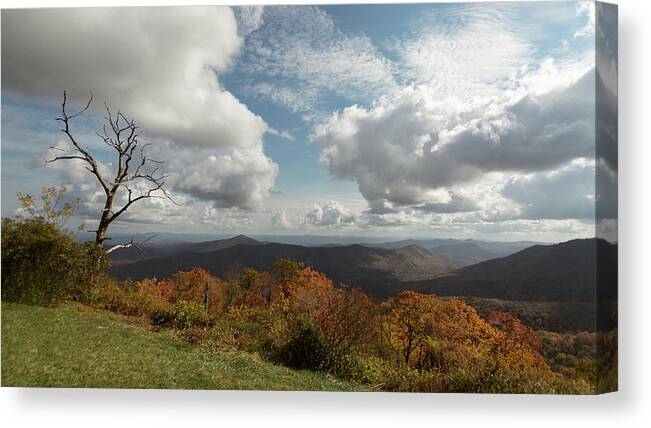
[111,235,617,302]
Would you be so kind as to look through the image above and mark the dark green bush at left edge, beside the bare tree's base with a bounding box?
[2,219,108,305]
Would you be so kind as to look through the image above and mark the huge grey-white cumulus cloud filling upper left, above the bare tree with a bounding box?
[2,7,277,209]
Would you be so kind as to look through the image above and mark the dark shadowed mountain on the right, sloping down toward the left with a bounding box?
[404,239,617,302]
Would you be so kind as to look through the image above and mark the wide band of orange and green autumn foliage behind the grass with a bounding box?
[88,260,594,393]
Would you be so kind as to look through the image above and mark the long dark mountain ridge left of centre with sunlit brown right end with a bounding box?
[110,236,463,296]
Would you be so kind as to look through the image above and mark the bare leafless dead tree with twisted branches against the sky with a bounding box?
[46,92,174,252]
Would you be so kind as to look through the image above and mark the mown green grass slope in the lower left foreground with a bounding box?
[2,303,363,391]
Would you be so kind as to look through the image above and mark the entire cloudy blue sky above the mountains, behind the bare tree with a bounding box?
[1,2,617,241]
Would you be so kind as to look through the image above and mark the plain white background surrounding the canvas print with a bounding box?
[0,0,651,428]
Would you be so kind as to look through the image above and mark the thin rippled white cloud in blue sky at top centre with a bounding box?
[237,6,396,113]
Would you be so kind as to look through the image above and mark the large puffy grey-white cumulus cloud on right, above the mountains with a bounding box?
[312,69,594,217]
